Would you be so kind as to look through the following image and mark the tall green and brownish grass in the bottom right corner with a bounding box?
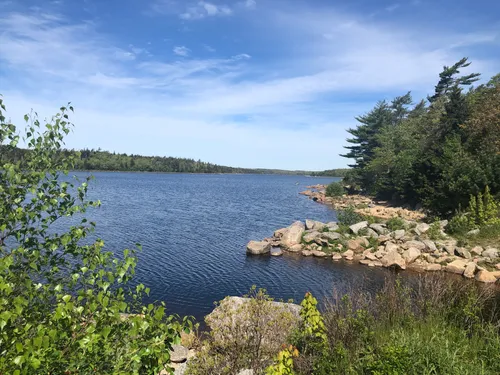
[291,274,500,375]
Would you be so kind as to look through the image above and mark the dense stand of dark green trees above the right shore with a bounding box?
[343,58,500,218]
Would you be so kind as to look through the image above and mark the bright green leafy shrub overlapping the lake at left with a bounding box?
[0,98,189,375]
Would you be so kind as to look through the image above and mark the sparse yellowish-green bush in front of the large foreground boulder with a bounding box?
[187,286,296,375]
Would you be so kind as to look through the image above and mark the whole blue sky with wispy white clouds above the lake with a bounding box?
[0,0,500,170]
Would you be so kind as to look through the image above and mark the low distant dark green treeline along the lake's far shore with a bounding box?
[0,145,348,176]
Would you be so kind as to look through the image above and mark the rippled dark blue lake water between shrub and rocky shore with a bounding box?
[76,172,388,319]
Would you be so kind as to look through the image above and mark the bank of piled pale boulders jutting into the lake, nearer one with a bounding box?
[247,220,500,283]
